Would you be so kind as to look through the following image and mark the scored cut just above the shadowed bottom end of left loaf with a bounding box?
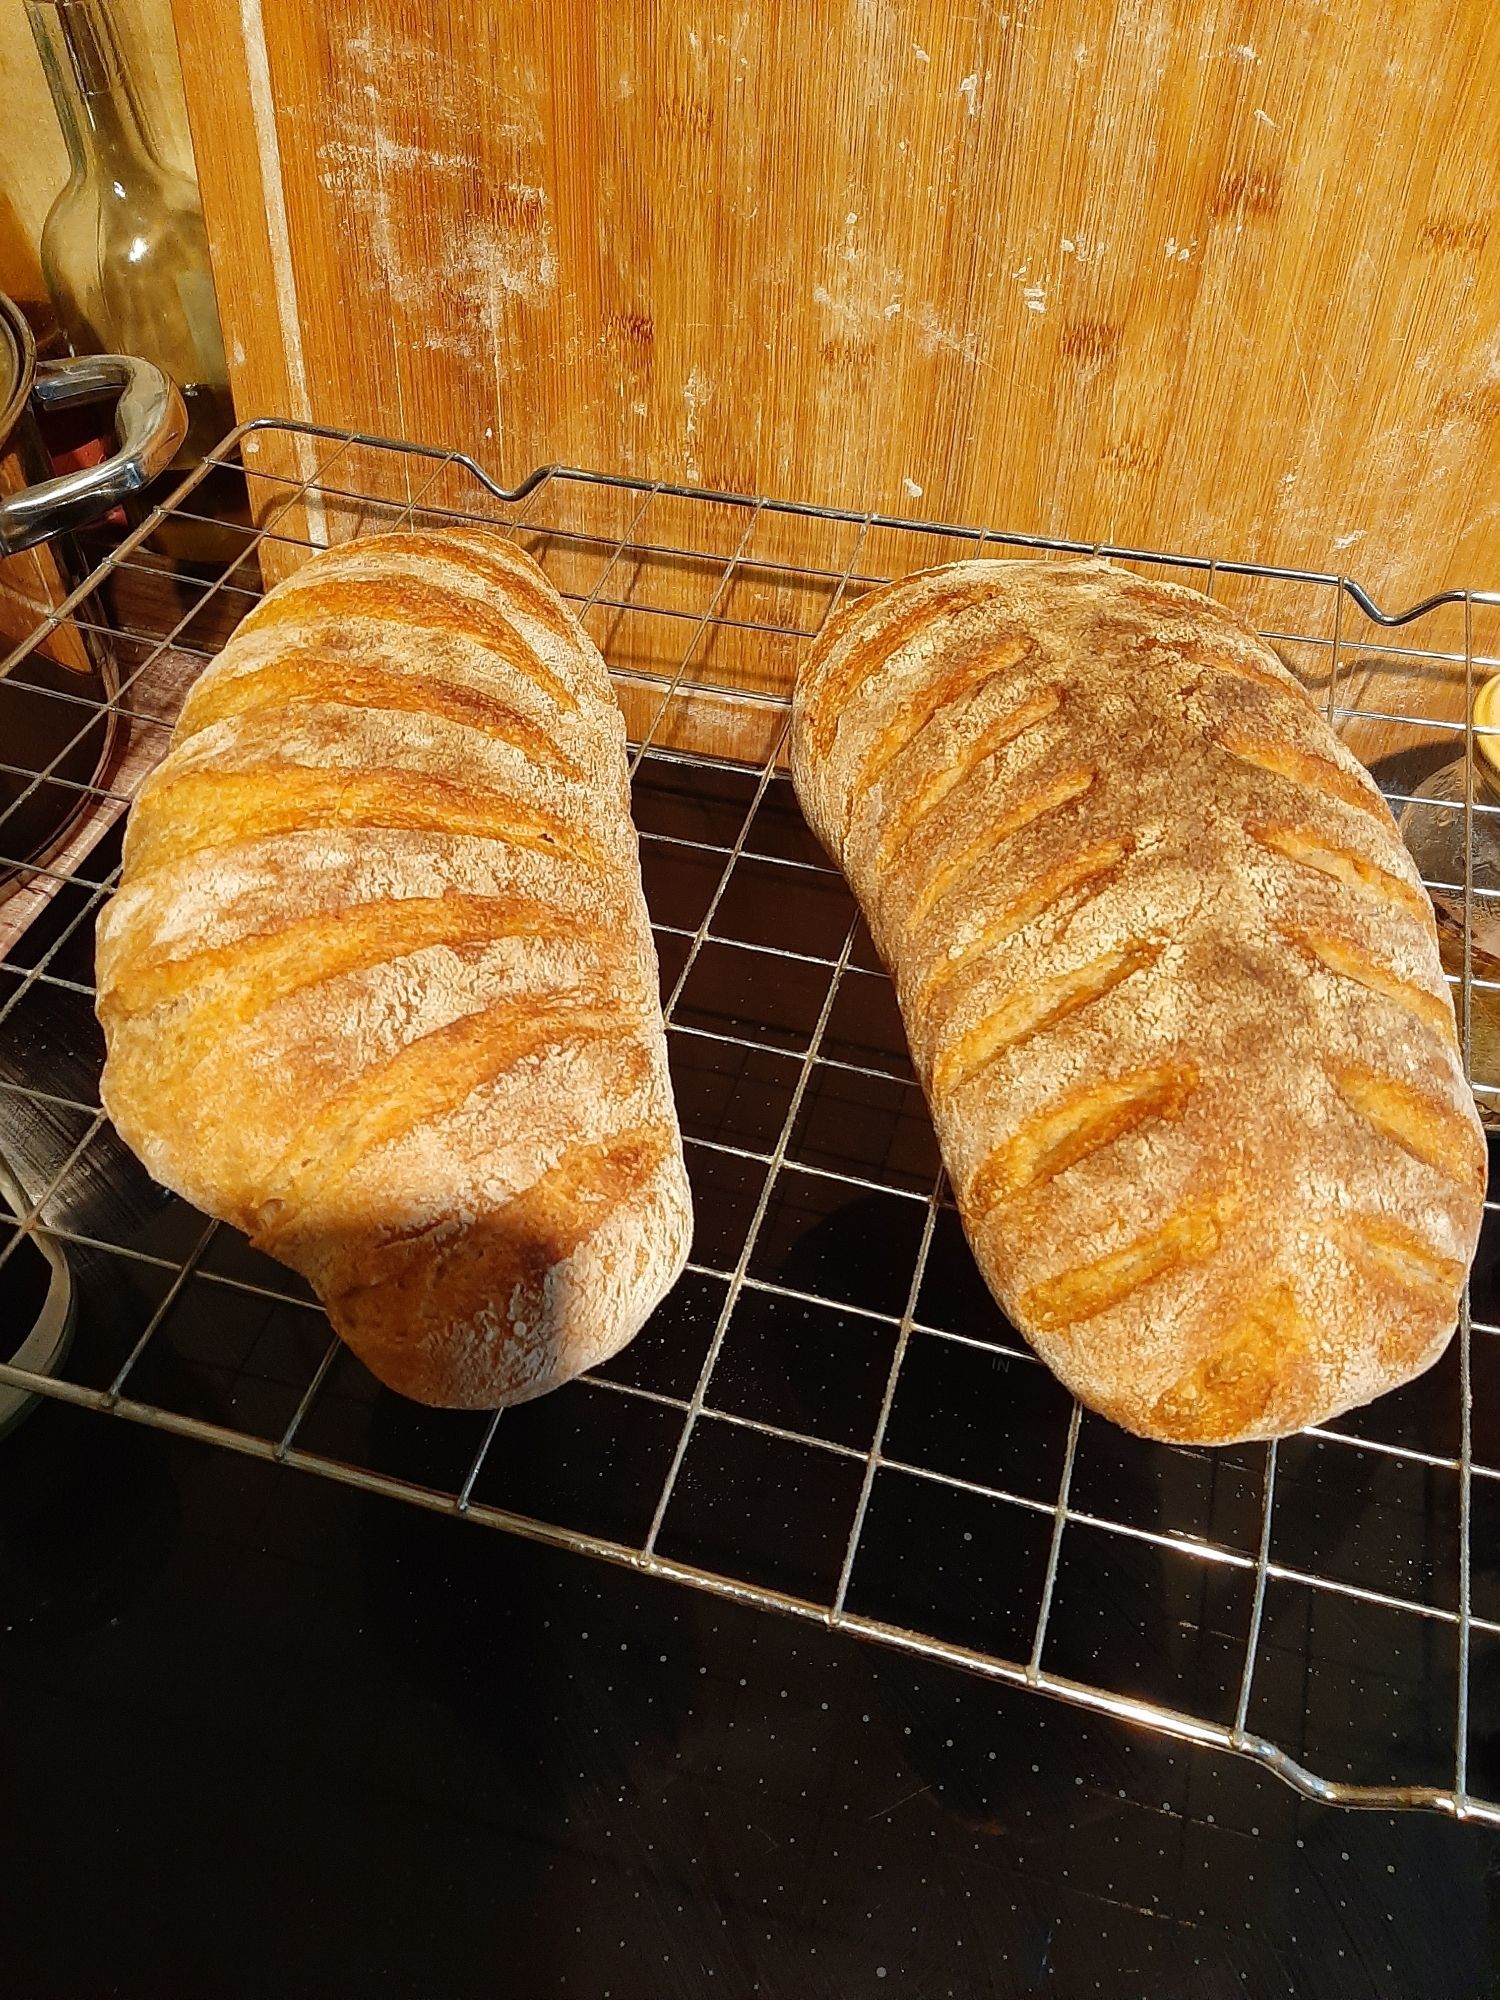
[254,990,648,1252]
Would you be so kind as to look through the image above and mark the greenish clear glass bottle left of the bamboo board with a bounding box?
[26,0,244,560]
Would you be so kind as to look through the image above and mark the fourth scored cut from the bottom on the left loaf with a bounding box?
[126,764,600,874]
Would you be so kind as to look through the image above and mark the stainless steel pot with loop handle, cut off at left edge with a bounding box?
[0,294,188,896]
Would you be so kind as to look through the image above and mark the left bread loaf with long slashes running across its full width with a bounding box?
[98,528,692,1408]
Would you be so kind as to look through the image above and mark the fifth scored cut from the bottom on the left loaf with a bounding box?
[174,646,582,778]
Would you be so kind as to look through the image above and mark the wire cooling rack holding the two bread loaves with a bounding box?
[0,422,1500,1824]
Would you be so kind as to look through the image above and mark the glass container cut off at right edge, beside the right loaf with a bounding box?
[1400,674,1500,1130]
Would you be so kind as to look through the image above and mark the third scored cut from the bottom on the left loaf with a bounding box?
[100,896,604,1028]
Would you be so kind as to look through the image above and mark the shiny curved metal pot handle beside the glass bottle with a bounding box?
[0,354,188,556]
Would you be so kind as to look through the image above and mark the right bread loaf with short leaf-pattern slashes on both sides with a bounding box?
[792,562,1486,1444]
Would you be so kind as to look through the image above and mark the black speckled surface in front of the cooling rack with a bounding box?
[0,1404,1500,2000]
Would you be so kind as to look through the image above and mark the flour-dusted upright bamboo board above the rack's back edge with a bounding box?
[176,0,1500,764]
